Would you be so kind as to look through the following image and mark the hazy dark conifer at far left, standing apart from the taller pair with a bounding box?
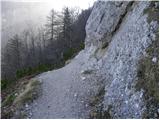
[2,34,22,79]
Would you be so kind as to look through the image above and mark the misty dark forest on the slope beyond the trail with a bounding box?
[1,7,92,89]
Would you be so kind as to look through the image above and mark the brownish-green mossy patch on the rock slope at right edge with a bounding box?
[136,31,159,118]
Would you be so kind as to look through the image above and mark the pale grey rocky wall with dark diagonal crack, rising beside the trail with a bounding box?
[80,1,158,118]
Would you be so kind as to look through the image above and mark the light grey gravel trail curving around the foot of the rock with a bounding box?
[30,52,92,119]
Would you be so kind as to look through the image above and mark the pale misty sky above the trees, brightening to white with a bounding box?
[1,0,96,48]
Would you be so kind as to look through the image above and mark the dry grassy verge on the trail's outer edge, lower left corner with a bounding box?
[1,77,41,119]
